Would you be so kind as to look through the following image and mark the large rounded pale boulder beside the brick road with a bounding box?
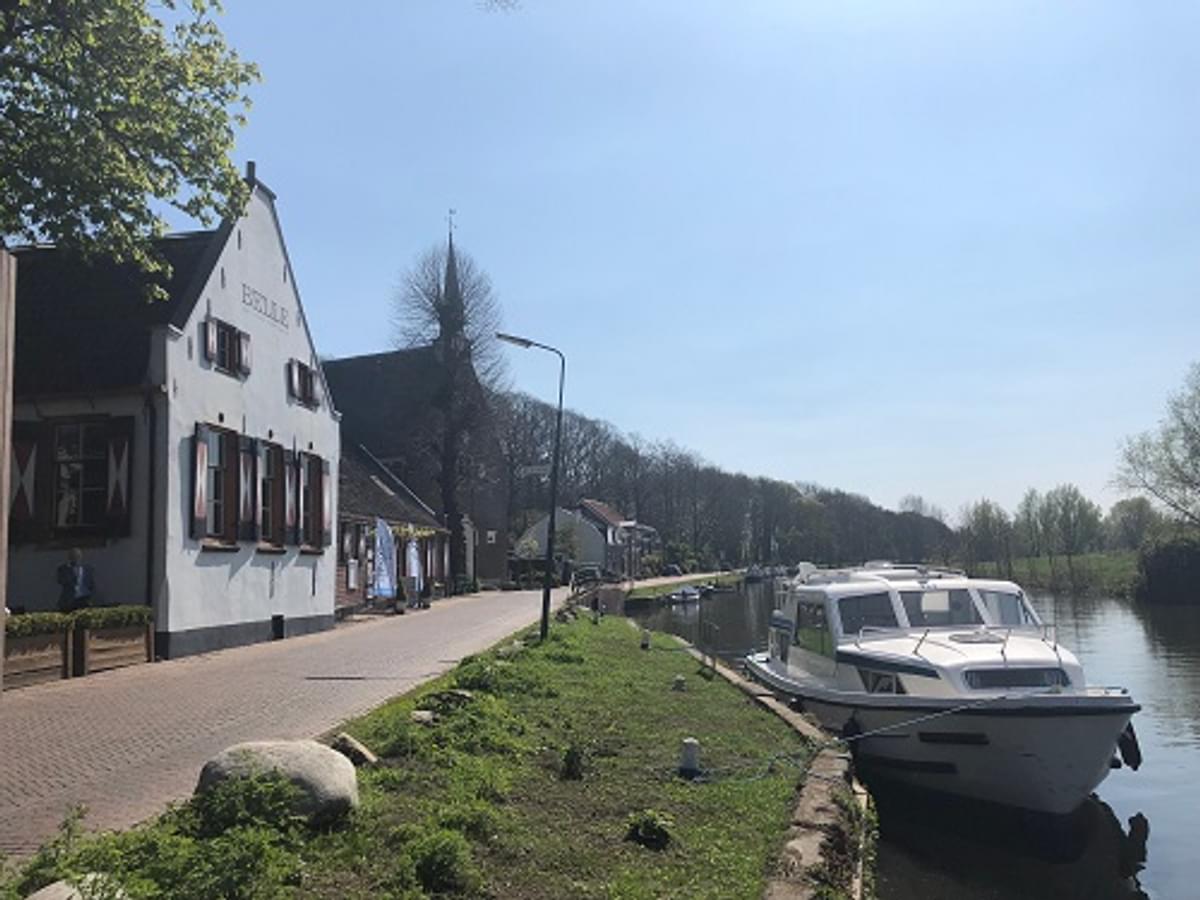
[196,740,359,822]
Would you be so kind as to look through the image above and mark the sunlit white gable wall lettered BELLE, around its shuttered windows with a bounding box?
[158,181,338,632]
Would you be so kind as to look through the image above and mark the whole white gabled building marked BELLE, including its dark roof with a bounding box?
[7,163,340,656]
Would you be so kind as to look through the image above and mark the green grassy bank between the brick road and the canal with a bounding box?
[0,619,809,900]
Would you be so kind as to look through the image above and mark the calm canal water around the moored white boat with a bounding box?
[630,582,1200,900]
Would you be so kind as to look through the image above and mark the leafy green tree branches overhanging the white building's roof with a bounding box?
[0,0,258,277]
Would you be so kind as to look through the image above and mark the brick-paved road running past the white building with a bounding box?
[0,590,564,856]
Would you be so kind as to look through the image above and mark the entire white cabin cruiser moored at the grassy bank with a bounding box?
[746,564,1140,815]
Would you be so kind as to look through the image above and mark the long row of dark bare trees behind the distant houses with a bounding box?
[492,392,954,568]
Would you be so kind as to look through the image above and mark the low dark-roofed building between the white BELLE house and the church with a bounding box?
[337,444,449,614]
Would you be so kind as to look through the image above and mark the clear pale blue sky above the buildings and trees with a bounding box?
[204,0,1200,516]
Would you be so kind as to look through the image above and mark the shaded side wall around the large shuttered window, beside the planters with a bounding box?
[7,395,148,612]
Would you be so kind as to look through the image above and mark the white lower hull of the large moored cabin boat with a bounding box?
[748,660,1138,815]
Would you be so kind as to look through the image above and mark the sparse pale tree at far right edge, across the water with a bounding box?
[1116,362,1200,526]
